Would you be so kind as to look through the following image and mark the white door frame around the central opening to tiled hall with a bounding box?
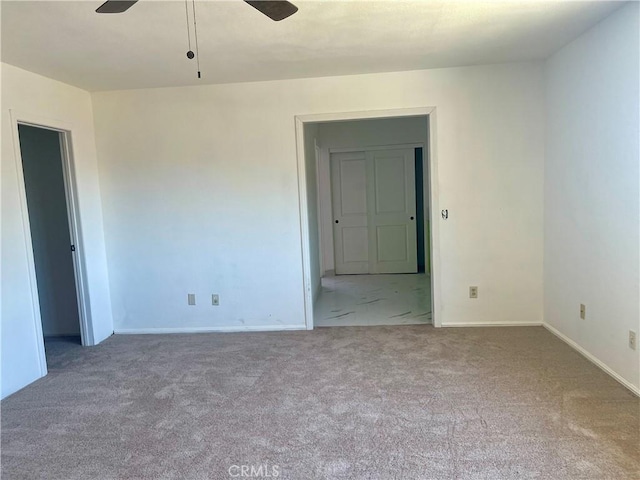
[294,107,442,330]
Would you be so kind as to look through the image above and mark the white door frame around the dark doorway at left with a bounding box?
[9,109,94,375]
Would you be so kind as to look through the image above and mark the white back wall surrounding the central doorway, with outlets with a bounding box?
[93,64,544,331]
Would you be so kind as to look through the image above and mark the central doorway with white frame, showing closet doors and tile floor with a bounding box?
[296,108,440,329]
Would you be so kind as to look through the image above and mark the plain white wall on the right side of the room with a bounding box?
[544,2,640,388]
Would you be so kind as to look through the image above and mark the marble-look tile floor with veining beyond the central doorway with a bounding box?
[314,273,432,327]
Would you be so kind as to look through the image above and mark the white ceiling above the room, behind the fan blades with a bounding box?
[1,0,622,91]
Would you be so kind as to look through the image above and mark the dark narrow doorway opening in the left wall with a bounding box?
[17,123,85,350]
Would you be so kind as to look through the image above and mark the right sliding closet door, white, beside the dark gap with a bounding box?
[366,149,418,273]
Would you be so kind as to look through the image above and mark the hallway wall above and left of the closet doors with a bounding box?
[318,117,428,273]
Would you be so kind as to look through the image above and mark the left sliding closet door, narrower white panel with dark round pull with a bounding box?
[331,152,369,275]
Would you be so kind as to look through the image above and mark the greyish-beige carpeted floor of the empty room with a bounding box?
[2,326,640,480]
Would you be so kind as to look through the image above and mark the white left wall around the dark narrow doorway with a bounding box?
[1,63,113,397]
